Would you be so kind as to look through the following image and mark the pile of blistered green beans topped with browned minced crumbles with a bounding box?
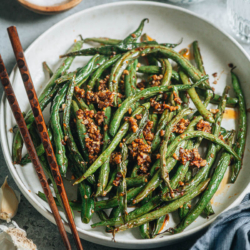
[15,19,247,239]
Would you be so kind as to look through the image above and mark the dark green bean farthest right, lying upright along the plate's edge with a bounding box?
[231,72,247,182]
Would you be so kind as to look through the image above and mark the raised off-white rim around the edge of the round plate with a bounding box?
[0,1,250,247]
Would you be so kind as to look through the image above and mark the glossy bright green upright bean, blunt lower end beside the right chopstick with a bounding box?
[51,84,68,176]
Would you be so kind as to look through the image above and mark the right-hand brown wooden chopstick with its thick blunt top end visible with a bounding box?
[7,26,83,250]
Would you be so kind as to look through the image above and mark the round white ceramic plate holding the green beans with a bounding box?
[1,1,250,248]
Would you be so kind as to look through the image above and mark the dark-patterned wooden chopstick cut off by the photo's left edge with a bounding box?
[0,55,71,249]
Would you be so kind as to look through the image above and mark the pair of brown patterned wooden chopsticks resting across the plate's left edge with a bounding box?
[0,26,83,250]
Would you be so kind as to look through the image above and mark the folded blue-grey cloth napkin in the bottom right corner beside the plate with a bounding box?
[190,194,250,250]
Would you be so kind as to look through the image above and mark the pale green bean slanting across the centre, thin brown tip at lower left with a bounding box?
[74,103,150,185]
